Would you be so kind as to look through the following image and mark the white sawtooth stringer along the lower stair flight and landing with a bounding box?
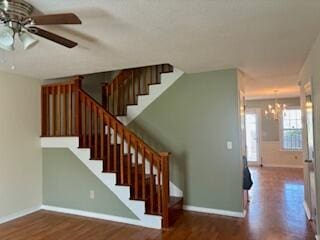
[41,137,162,229]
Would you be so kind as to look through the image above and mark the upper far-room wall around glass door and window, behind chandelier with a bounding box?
[246,97,300,142]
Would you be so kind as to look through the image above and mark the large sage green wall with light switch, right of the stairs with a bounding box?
[129,69,242,211]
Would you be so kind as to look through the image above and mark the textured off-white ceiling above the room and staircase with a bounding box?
[0,0,320,95]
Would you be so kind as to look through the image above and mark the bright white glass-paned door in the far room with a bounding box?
[245,109,261,166]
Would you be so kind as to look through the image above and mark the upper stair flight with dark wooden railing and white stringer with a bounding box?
[102,64,183,125]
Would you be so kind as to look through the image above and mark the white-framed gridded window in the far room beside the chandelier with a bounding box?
[282,108,302,150]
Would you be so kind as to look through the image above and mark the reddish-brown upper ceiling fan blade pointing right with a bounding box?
[31,13,81,25]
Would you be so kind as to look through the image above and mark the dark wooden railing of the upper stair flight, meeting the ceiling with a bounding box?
[102,64,173,116]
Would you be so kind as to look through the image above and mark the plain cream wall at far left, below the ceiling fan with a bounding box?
[0,72,42,223]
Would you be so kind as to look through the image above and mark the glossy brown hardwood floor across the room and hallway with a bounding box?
[0,168,314,240]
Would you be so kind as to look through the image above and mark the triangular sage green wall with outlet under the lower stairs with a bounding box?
[43,149,137,219]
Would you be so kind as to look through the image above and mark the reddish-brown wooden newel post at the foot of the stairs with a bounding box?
[160,152,170,228]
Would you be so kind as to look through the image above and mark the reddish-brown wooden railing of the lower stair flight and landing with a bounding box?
[41,77,175,228]
